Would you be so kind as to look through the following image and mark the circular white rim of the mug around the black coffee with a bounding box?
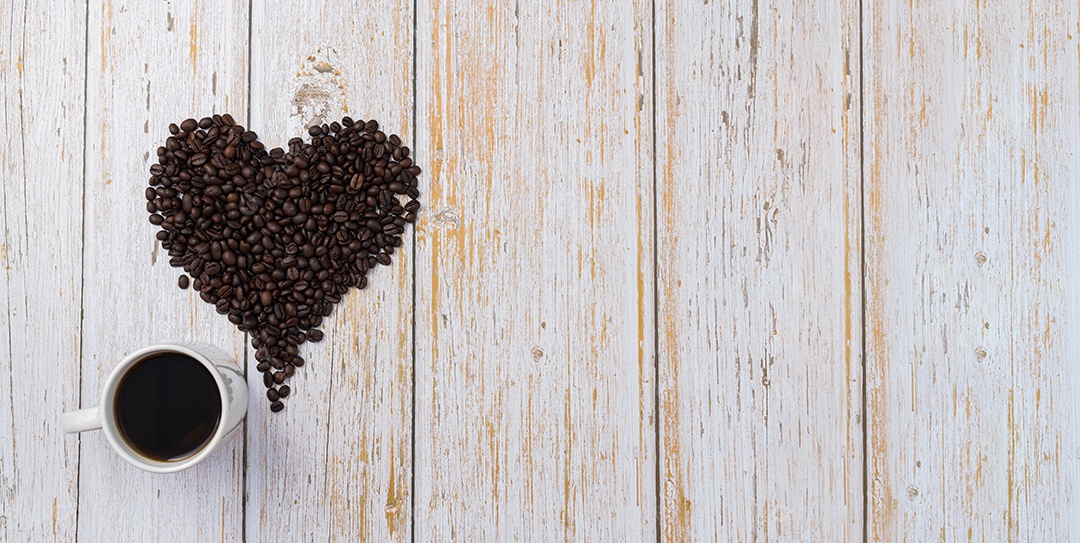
[100,343,230,473]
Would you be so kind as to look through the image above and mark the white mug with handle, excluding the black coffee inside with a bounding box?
[60,343,247,473]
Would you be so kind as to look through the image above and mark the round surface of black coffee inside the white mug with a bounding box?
[116,353,221,462]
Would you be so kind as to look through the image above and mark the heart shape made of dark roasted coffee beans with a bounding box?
[146,114,420,411]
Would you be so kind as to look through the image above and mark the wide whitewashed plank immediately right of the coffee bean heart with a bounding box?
[415,0,657,541]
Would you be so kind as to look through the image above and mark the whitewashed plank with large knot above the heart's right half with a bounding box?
[247,0,413,541]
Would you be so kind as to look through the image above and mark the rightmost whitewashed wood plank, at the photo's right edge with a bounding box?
[864,0,1080,541]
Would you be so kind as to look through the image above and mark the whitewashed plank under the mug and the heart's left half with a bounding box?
[79,0,248,541]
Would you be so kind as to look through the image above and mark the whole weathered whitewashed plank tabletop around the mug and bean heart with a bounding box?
[0,0,1080,542]
